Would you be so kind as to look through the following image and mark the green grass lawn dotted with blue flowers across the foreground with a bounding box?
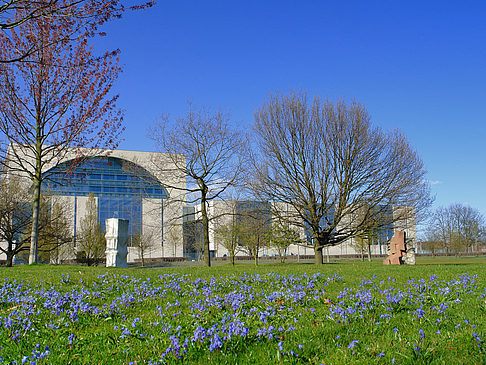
[0,258,486,364]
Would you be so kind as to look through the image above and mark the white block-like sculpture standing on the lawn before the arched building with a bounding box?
[105,218,128,267]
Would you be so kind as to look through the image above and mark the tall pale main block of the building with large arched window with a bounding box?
[0,145,186,262]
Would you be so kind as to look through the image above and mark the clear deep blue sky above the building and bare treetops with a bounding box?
[98,0,486,219]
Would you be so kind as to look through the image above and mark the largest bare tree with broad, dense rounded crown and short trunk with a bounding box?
[253,92,431,264]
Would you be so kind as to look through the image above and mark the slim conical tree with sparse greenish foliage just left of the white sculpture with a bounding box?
[76,193,106,266]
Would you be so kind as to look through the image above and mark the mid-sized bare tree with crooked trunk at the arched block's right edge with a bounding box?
[151,107,247,266]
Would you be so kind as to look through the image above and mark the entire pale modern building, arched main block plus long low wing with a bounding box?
[0,149,416,262]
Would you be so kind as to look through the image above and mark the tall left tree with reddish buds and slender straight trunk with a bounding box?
[0,6,123,263]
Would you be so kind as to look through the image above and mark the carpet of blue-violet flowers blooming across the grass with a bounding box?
[0,273,486,364]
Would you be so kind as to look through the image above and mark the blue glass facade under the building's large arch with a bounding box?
[43,157,167,239]
